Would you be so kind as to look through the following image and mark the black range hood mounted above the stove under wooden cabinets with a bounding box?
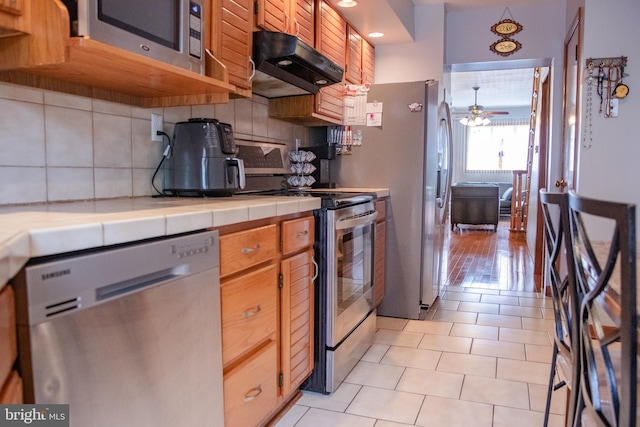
[252,31,344,98]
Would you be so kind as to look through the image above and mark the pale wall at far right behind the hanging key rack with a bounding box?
[577,0,640,211]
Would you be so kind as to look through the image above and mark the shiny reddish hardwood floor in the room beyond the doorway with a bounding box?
[442,219,538,292]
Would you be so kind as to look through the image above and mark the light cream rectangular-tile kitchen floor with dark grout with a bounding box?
[276,287,566,427]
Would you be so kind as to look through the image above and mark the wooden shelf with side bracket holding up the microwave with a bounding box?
[0,0,235,108]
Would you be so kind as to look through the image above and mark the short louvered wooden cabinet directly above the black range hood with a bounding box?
[256,0,315,47]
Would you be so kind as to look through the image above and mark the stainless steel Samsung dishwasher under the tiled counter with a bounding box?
[13,232,224,427]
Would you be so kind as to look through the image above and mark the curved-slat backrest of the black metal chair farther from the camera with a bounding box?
[540,189,581,362]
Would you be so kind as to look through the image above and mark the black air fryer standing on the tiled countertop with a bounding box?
[164,118,245,197]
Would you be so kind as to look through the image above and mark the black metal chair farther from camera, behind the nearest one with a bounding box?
[540,189,580,427]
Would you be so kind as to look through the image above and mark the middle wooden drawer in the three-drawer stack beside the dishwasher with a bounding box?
[220,265,278,365]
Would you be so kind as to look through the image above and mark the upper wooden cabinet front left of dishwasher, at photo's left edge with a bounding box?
[0,285,18,387]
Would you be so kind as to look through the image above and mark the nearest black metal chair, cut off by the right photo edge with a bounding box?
[569,193,638,427]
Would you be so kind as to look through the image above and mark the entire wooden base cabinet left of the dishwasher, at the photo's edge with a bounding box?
[0,285,22,405]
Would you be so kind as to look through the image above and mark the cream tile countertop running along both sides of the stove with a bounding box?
[0,188,389,289]
